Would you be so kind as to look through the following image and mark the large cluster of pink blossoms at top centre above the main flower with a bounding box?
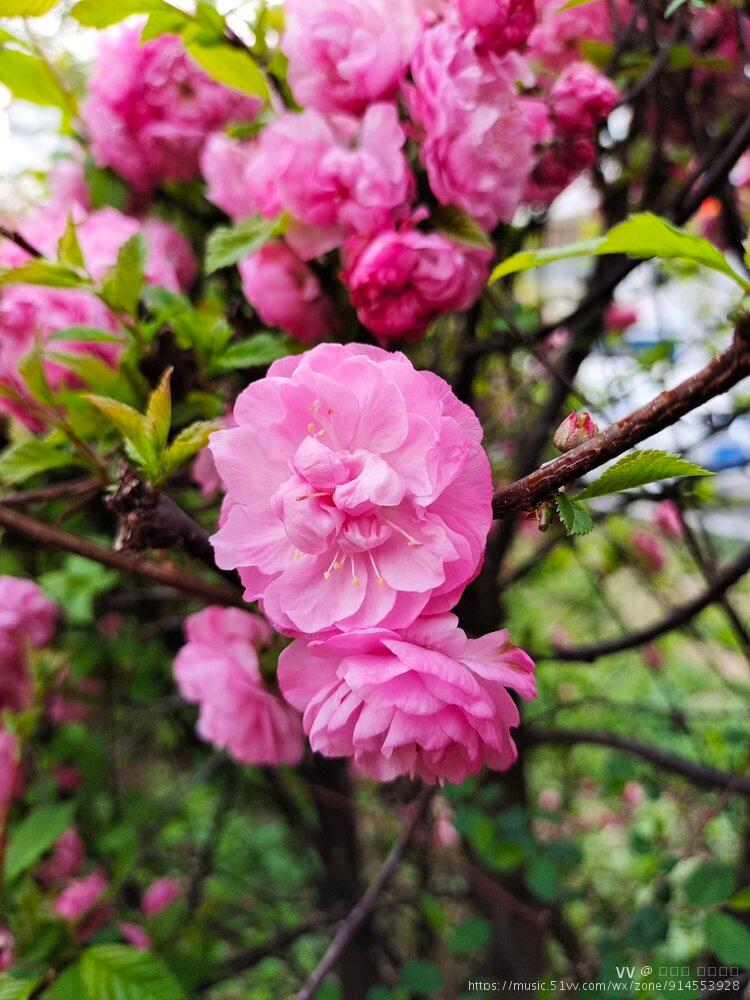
[201,0,627,343]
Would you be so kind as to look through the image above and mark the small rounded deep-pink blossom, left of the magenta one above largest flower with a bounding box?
[239,243,338,344]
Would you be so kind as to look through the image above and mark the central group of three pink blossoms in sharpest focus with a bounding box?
[181,344,535,783]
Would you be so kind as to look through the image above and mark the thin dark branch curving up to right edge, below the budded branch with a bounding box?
[536,547,750,663]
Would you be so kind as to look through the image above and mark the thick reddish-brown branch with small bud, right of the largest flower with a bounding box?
[492,321,750,518]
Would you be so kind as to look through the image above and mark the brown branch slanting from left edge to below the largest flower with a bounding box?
[0,504,245,608]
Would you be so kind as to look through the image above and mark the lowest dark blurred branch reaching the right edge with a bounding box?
[517,727,750,797]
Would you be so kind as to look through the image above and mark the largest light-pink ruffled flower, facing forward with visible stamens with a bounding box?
[210,344,492,635]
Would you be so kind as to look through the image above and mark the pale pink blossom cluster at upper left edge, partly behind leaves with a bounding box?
[0,178,197,431]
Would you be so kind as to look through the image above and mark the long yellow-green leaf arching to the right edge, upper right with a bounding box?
[490,212,750,291]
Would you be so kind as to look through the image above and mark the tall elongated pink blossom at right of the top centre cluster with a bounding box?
[406,21,533,230]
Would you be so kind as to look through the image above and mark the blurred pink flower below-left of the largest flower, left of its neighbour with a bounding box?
[174,608,302,764]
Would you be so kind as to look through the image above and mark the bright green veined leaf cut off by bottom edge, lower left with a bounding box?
[81,944,184,1000]
